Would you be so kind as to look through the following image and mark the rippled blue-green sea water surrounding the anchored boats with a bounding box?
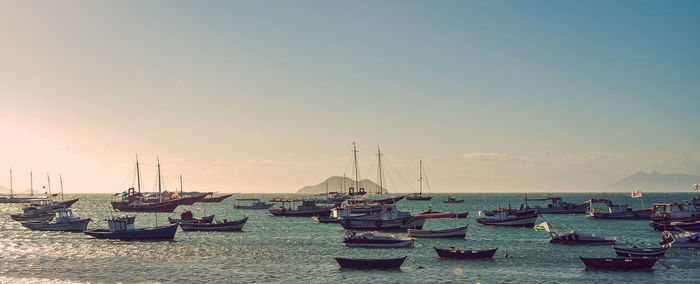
[0,193,700,283]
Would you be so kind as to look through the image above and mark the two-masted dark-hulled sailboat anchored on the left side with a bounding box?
[112,156,180,212]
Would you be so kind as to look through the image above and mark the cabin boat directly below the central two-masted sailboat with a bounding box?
[338,204,425,231]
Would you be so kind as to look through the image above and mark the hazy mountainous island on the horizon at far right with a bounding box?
[610,171,700,192]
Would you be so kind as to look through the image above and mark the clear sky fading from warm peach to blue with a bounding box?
[0,0,700,193]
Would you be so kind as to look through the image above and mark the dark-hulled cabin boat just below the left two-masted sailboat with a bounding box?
[84,216,178,241]
